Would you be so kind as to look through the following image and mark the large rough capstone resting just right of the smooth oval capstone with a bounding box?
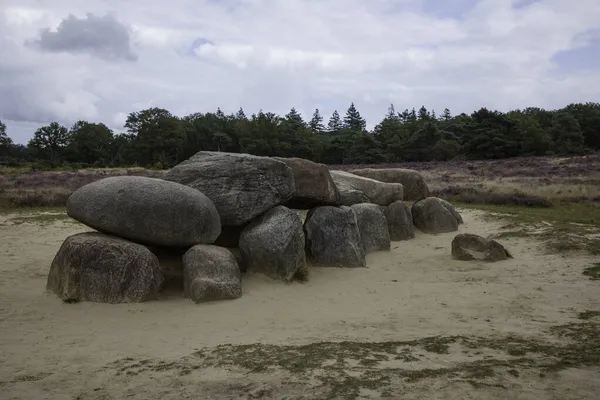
[164,151,295,226]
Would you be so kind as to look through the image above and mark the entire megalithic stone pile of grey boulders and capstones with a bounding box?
[47,151,462,303]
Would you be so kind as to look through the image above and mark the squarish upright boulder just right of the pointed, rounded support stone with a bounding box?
[304,206,367,268]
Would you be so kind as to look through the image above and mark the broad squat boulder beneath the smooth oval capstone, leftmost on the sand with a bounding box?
[46,232,163,303]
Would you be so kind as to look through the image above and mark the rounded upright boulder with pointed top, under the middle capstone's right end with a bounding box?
[240,206,307,282]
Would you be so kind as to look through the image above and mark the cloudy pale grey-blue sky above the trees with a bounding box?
[0,0,600,143]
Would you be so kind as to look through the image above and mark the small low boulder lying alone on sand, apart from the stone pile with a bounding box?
[452,233,512,262]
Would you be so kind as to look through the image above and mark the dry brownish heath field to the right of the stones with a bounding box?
[331,155,600,205]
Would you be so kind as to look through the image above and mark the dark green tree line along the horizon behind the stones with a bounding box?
[0,103,600,168]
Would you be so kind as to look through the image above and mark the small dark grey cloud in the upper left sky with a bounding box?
[27,13,137,61]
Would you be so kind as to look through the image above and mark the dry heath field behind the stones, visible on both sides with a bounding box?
[0,155,600,207]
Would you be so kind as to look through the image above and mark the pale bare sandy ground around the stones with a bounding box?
[0,210,600,400]
